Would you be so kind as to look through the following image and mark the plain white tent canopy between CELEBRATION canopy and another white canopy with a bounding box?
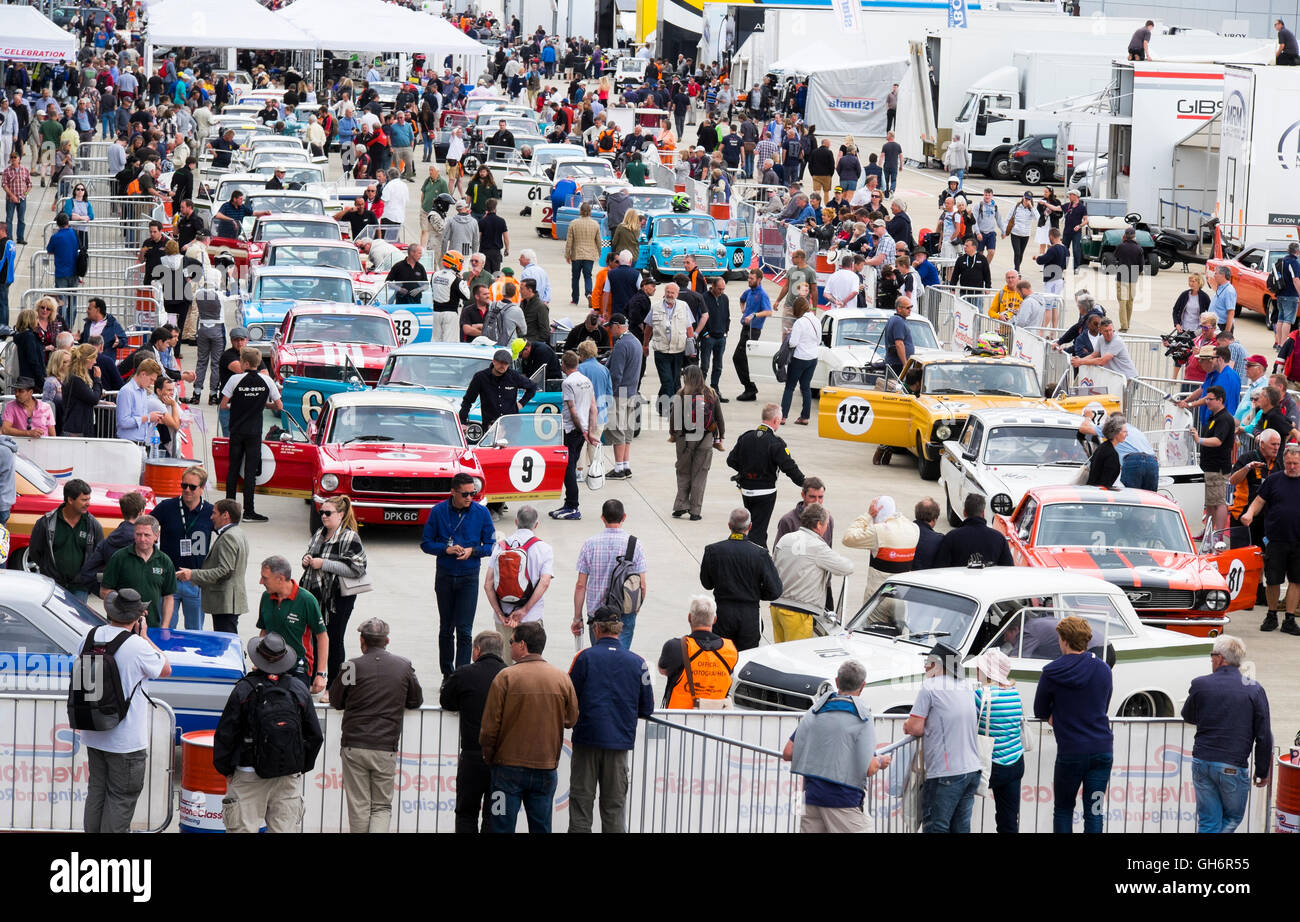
[148,0,319,49]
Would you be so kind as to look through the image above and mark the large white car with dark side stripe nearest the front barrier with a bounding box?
[731,567,1212,718]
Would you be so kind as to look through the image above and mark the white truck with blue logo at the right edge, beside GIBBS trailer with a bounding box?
[1218,64,1300,243]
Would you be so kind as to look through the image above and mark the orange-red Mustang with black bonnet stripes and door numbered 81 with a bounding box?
[995,486,1264,637]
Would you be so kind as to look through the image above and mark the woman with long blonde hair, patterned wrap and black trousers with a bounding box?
[299,497,367,683]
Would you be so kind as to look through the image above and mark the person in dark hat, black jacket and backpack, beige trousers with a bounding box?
[212,633,325,832]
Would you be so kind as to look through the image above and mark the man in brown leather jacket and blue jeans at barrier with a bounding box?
[478,622,577,832]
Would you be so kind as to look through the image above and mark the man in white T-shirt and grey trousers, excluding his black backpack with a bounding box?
[78,589,172,832]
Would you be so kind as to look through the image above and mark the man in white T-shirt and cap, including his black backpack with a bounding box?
[68,589,172,832]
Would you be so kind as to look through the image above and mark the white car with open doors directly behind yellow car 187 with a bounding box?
[745,307,940,390]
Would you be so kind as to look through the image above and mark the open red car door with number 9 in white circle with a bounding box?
[475,414,568,502]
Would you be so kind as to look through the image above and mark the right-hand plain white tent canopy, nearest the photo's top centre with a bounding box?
[276,0,488,59]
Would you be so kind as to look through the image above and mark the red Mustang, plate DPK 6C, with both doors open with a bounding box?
[212,390,568,532]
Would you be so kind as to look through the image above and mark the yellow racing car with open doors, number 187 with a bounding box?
[818,352,1121,480]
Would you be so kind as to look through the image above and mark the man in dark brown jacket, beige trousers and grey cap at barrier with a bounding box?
[329,618,424,832]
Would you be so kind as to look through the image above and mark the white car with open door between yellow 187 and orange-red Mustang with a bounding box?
[939,403,1205,527]
